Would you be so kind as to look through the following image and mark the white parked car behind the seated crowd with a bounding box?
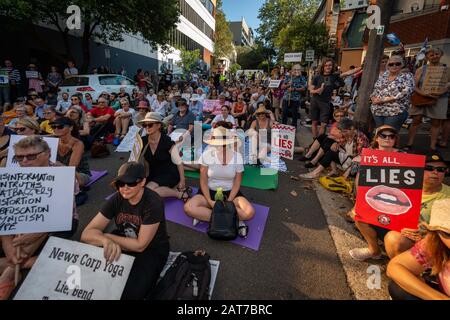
[58,74,138,101]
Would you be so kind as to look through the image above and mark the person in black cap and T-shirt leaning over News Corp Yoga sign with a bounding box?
[81,162,170,300]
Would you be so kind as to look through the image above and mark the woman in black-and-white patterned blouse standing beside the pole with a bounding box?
[370,56,414,130]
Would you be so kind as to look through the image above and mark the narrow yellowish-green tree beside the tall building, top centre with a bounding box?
[214,0,233,58]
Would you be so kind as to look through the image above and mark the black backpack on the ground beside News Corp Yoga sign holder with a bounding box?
[153,251,211,300]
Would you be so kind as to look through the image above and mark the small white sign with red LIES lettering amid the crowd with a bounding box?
[271,124,295,160]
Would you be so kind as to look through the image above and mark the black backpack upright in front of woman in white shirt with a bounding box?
[208,201,239,240]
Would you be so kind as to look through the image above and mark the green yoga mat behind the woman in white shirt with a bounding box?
[184,166,278,190]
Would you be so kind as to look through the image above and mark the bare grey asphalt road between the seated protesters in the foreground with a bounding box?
[75,148,353,300]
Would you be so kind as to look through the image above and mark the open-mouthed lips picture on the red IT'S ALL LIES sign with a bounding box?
[366,185,412,216]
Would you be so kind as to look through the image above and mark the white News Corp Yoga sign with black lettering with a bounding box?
[14,237,134,300]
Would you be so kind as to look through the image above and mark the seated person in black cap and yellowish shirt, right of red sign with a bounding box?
[349,151,450,261]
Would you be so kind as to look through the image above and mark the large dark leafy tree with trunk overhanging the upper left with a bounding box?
[0,0,179,72]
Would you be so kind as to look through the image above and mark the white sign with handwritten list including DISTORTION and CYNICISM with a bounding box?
[0,167,75,235]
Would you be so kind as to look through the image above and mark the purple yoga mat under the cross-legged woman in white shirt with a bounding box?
[106,188,270,251]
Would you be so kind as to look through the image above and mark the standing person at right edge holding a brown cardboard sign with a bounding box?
[405,48,450,150]
